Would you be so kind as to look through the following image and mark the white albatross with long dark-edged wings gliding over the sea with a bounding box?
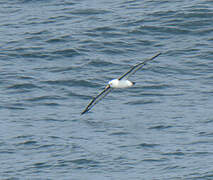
[81,53,161,114]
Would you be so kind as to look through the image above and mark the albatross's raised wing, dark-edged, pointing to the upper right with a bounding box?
[118,53,161,80]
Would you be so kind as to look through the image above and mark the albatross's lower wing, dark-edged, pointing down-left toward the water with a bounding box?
[81,86,111,115]
